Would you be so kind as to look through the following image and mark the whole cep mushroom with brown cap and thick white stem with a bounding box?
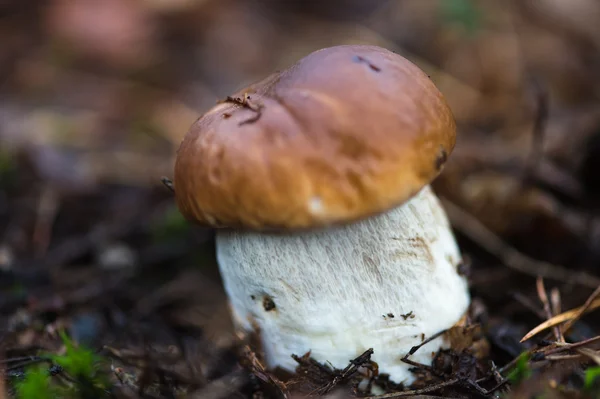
[174,45,470,384]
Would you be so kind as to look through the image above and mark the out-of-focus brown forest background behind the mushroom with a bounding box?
[0,0,600,398]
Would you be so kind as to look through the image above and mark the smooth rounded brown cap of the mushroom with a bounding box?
[174,45,456,229]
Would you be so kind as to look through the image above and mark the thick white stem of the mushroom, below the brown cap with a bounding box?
[216,186,470,384]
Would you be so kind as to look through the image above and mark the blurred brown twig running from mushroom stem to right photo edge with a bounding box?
[440,197,600,288]
